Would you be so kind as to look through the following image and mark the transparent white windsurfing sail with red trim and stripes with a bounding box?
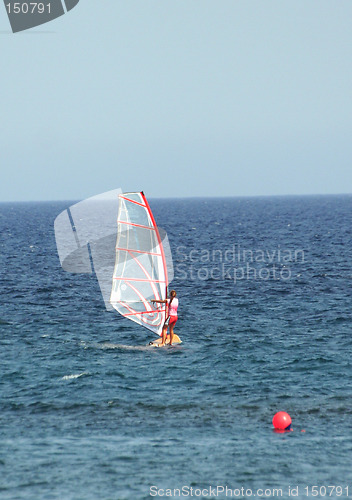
[110,192,168,335]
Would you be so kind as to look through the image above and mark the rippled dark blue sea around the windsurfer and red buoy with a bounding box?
[0,195,352,500]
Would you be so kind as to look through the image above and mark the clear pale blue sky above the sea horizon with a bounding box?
[0,0,352,201]
